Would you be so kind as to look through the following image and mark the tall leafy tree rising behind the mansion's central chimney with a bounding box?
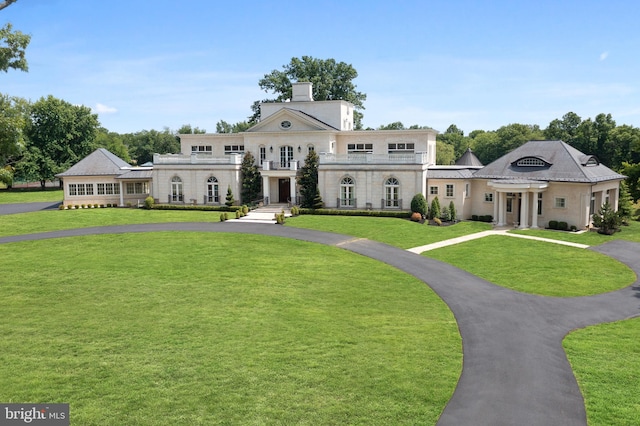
[251,56,367,129]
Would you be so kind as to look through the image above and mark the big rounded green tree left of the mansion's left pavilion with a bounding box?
[20,95,100,187]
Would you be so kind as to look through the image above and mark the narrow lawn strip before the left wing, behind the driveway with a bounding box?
[0,208,220,236]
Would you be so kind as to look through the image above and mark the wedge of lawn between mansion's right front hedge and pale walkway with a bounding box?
[286,215,491,249]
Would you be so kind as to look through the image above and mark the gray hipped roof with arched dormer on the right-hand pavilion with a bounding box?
[473,141,625,183]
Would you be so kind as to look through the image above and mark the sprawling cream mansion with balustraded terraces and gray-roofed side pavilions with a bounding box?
[57,83,624,228]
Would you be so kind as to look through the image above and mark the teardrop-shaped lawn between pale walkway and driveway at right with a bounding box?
[424,235,636,297]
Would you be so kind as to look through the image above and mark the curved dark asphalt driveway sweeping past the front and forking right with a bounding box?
[0,221,640,426]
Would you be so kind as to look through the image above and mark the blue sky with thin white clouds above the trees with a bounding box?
[0,0,640,134]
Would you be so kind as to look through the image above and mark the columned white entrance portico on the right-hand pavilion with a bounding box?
[487,179,549,229]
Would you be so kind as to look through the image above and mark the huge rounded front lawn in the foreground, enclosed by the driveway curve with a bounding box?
[0,233,462,425]
